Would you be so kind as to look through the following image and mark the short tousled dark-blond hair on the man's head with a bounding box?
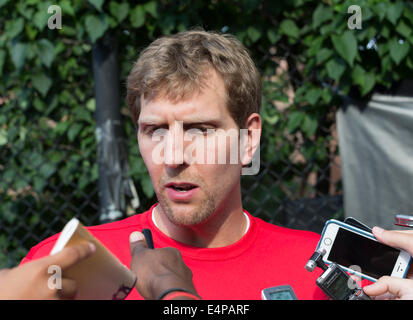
[126,30,262,128]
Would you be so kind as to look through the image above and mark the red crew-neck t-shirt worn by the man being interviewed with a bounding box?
[22,205,327,300]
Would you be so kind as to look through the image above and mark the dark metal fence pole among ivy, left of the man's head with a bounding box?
[92,34,127,223]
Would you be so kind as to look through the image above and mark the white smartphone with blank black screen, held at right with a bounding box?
[317,219,412,282]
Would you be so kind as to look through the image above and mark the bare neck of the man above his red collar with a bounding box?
[152,205,249,248]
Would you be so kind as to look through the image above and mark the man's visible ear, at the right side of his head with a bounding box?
[240,113,261,167]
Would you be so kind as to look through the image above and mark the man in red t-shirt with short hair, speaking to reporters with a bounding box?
[23,31,326,299]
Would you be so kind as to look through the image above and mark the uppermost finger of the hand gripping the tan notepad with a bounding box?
[46,242,96,269]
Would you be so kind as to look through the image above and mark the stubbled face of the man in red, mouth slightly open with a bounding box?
[138,72,242,226]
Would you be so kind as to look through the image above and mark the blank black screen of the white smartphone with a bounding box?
[328,228,400,279]
